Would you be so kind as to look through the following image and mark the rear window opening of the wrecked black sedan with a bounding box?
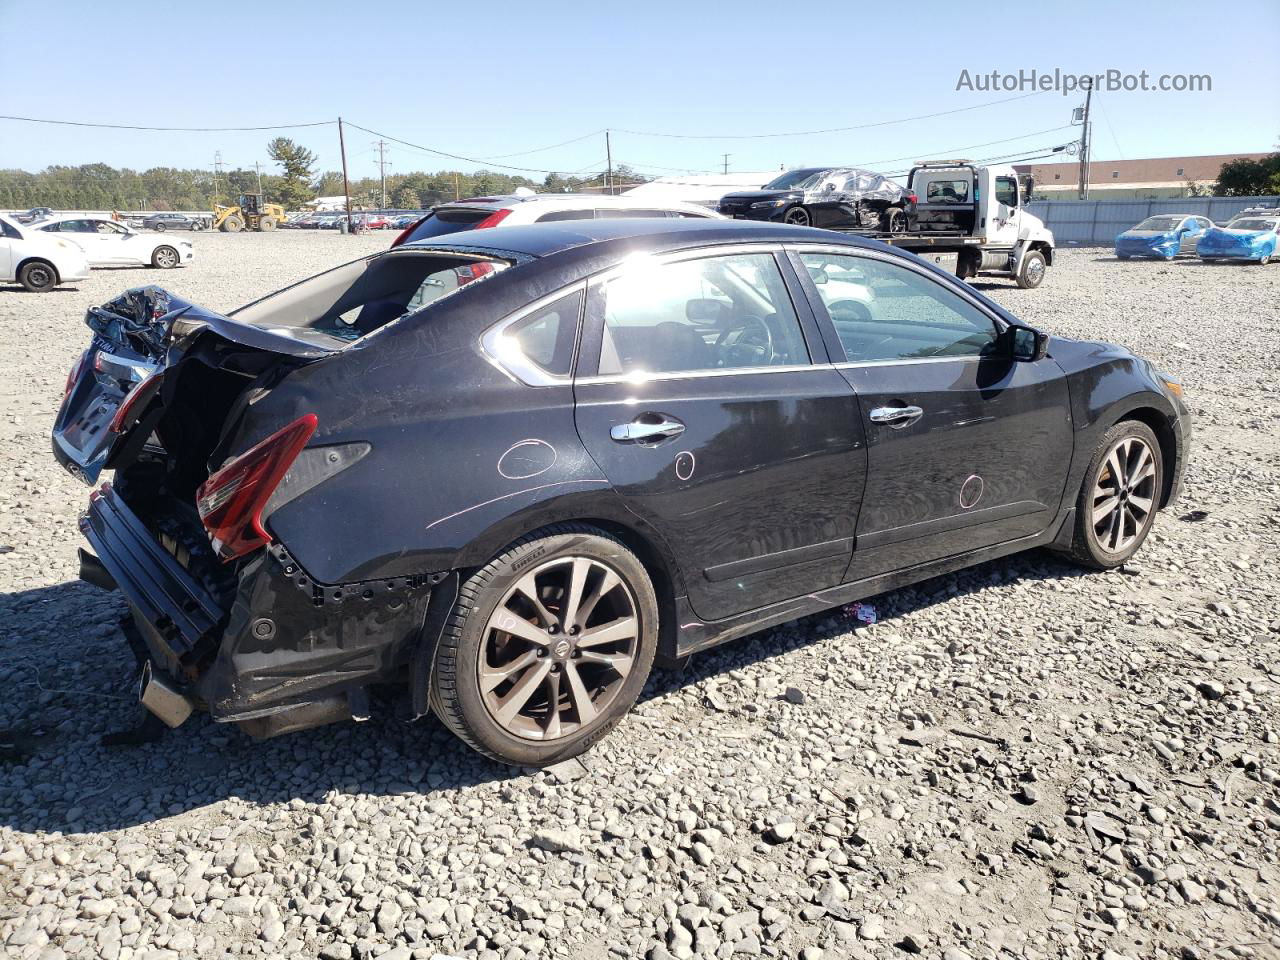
[228,251,511,340]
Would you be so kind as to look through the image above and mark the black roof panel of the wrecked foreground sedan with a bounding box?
[396,218,883,257]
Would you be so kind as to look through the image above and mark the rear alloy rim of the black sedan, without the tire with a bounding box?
[477,557,640,741]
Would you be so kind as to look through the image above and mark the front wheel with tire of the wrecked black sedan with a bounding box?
[1066,420,1165,570]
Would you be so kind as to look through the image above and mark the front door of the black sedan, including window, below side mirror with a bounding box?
[795,250,1073,580]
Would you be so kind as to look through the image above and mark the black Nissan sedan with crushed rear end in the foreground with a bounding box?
[54,220,1189,764]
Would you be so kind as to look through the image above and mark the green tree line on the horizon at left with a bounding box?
[0,137,646,211]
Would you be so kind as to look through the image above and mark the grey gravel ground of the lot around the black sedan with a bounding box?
[0,233,1280,960]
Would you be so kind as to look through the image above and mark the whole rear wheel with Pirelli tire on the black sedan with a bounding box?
[430,524,658,767]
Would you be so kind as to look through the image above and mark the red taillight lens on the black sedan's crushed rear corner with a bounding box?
[196,413,319,562]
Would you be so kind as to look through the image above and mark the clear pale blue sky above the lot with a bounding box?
[0,0,1280,179]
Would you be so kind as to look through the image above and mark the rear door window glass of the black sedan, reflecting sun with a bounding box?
[600,253,809,375]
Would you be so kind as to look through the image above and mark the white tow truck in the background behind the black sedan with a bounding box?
[858,160,1053,289]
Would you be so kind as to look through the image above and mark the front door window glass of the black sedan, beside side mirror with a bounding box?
[800,253,1000,361]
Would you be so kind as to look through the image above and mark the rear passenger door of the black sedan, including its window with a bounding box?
[575,244,867,620]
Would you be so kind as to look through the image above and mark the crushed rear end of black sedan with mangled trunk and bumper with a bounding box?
[52,287,430,736]
